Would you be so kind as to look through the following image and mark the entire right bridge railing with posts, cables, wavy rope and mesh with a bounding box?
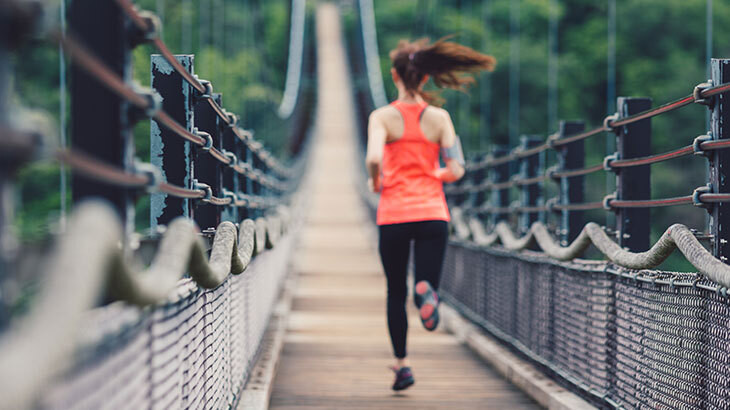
[342,1,730,409]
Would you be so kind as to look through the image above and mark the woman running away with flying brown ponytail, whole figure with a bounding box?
[366,39,496,390]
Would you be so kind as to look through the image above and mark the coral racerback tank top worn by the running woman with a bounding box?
[376,101,450,225]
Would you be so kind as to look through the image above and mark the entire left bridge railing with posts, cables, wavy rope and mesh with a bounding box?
[0,0,313,409]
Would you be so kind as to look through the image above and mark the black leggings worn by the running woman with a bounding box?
[378,221,448,359]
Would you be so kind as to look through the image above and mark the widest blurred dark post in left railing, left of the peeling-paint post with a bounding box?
[68,0,134,224]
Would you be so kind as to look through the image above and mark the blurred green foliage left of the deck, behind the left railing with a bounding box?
[13,0,294,241]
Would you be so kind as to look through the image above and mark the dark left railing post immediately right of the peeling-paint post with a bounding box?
[193,94,223,231]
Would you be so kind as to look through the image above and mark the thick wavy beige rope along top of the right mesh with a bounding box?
[452,209,730,287]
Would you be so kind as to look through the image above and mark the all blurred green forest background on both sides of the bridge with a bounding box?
[13,0,730,270]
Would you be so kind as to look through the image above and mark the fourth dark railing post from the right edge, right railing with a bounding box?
[519,135,545,233]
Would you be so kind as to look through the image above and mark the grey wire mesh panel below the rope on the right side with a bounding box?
[441,242,730,409]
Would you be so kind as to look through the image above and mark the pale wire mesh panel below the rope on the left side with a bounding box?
[40,232,292,410]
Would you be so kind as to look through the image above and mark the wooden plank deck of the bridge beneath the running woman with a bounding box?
[270,4,537,410]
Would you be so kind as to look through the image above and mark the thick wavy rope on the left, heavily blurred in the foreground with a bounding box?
[0,201,288,409]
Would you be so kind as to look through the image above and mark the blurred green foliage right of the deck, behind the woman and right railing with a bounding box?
[342,0,730,270]
